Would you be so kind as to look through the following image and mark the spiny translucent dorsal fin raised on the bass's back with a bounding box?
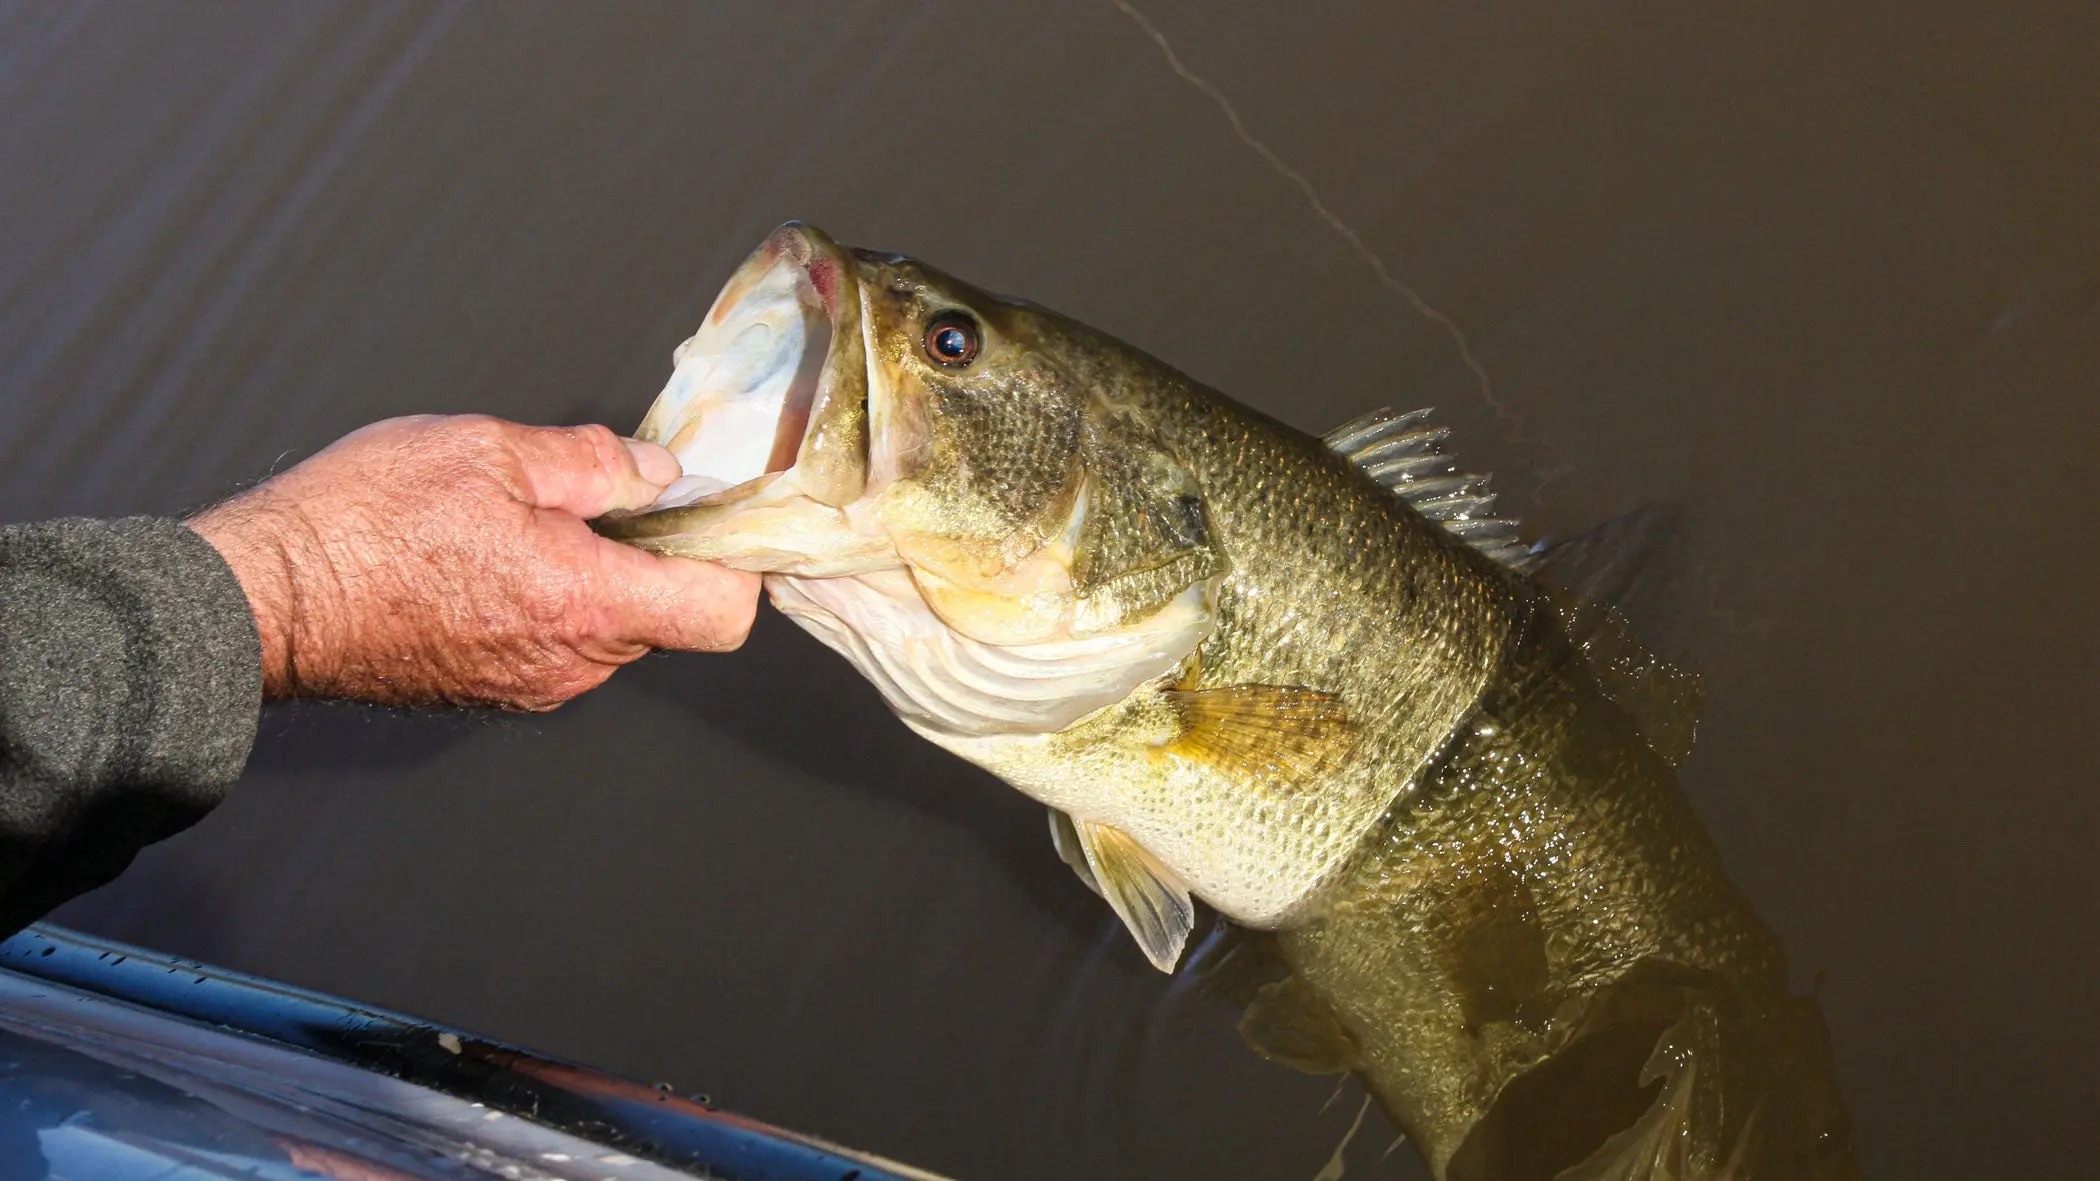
[1323,408,1531,569]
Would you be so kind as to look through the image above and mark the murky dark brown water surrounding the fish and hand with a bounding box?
[0,0,2100,1181]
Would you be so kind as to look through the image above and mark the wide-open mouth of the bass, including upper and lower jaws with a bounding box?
[594,223,874,574]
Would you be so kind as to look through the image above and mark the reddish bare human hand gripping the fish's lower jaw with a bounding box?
[189,416,758,710]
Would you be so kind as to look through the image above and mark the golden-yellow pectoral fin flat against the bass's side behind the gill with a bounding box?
[1168,685,1357,790]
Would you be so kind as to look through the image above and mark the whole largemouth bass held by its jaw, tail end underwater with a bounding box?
[599,225,1856,1181]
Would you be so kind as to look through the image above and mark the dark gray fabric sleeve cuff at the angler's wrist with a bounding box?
[0,517,263,935]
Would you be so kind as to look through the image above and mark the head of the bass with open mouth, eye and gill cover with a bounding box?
[599,223,1220,647]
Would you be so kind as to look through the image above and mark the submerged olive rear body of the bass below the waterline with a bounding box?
[1250,601,1856,1179]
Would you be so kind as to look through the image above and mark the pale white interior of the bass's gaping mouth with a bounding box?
[636,223,859,509]
